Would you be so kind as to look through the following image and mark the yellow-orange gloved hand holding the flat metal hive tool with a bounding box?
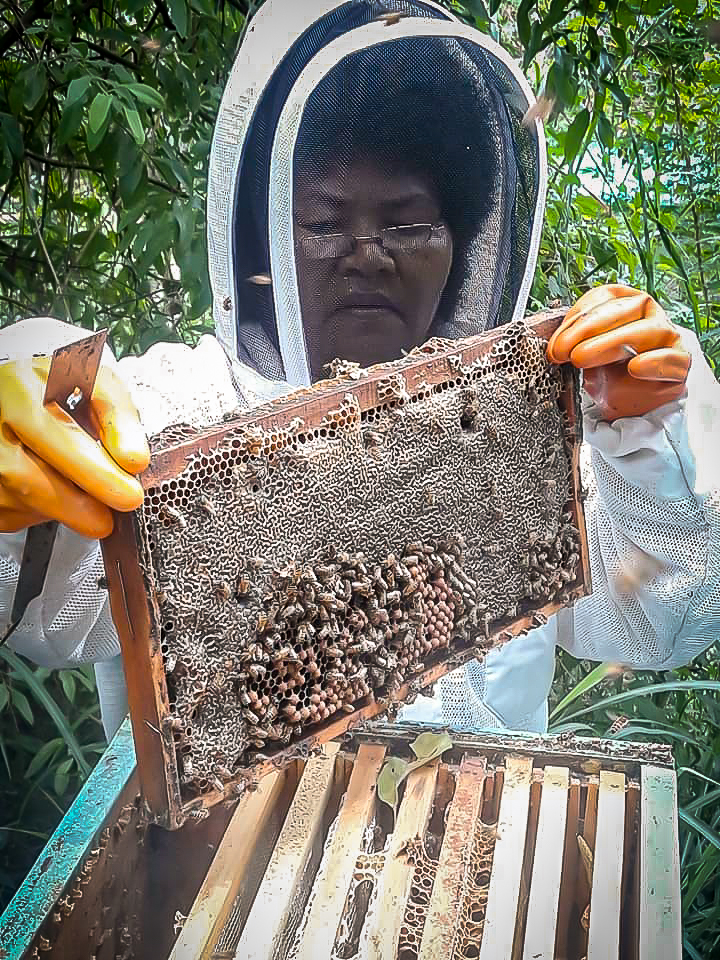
[0,357,150,538]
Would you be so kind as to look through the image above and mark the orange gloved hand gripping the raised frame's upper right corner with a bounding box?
[547,284,691,420]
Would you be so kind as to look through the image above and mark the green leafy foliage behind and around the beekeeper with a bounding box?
[0,0,720,960]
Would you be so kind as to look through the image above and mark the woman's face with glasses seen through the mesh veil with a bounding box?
[295,160,452,380]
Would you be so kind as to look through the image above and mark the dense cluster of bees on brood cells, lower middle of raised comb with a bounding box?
[238,543,474,728]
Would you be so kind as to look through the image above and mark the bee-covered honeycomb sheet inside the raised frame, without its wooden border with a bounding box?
[144,322,580,795]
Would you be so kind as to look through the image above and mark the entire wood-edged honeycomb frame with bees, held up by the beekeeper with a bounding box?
[104,312,590,828]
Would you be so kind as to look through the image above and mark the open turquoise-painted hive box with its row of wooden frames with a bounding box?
[0,725,681,960]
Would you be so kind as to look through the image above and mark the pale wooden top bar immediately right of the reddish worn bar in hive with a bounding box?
[480,757,533,960]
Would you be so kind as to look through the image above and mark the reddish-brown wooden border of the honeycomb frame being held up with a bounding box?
[103,311,590,829]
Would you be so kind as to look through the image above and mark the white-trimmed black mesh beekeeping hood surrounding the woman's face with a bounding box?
[208,0,546,386]
